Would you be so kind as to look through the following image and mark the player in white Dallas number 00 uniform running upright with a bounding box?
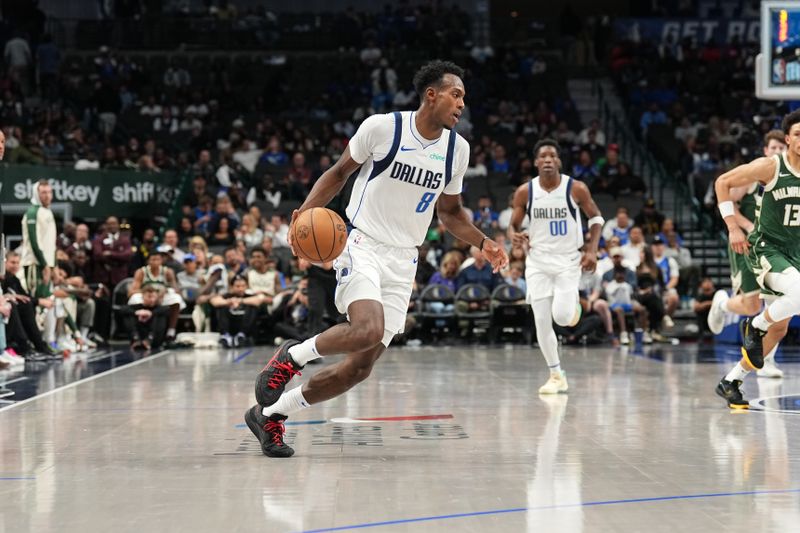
[508,139,605,394]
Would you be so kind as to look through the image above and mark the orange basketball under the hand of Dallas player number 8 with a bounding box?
[292,207,347,263]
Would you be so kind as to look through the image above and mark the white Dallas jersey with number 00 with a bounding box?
[528,174,583,262]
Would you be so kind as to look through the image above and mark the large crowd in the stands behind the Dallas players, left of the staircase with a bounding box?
[0,3,724,366]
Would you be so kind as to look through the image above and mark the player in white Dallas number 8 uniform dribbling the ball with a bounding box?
[245,61,508,457]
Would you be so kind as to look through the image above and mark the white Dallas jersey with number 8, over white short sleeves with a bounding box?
[347,111,469,248]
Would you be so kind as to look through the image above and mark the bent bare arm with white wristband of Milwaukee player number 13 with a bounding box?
[714,157,777,254]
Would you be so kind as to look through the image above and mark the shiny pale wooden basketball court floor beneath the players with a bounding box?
[0,345,800,533]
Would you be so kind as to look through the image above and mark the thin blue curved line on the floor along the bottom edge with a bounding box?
[300,488,800,533]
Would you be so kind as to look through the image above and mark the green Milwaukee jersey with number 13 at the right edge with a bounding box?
[755,154,800,248]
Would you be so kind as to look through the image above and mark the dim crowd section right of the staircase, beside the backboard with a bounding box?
[609,8,786,219]
